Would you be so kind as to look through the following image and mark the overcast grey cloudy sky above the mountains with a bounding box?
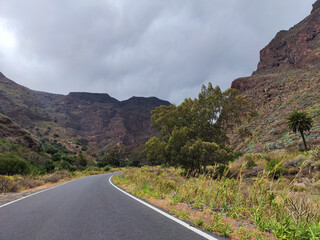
[0,0,315,104]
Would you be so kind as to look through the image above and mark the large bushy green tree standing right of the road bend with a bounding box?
[145,83,251,174]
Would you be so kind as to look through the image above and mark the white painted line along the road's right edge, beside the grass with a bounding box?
[109,175,219,240]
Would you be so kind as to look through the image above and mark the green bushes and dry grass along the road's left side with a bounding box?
[0,139,116,194]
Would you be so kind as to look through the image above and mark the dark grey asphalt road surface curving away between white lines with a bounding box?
[0,174,225,240]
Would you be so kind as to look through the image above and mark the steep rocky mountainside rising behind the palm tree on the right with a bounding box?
[231,0,320,152]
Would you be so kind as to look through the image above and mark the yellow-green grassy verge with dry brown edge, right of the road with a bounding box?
[114,151,320,240]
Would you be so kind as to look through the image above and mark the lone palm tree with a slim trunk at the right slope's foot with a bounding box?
[287,111,313,150]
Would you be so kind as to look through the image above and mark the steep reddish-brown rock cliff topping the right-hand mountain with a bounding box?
[257,1,320,71]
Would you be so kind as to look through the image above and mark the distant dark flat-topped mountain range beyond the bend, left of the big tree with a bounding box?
[0,73,170,149]
